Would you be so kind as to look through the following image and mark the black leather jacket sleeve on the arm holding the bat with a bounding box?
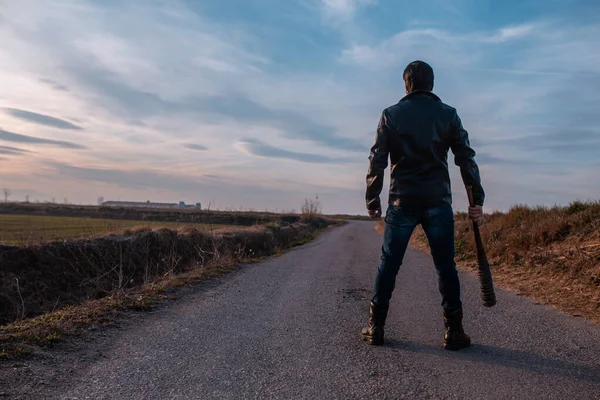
[451,114,485,206]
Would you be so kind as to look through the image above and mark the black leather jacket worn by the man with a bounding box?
[366,91,485,210]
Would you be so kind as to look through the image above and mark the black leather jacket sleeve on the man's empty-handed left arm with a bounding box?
[366,111,390,210]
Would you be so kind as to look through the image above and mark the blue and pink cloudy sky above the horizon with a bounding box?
[0,0,600,214]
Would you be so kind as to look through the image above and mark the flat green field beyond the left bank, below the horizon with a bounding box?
[0,215,230,246]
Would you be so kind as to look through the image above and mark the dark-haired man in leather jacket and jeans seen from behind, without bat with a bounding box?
[361,61,484,350]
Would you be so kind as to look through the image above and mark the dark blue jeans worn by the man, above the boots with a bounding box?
[371,204,462,310]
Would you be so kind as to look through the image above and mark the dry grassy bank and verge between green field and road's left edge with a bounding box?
[0,219,328,358]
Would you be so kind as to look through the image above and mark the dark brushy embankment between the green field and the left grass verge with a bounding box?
[0,219,327,325]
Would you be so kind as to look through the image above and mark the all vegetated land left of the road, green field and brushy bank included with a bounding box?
[0,200,338,358]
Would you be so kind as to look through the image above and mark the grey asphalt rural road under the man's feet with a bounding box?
[4,222,600,400]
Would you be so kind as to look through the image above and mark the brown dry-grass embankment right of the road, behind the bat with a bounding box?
[404,202,600,323]
